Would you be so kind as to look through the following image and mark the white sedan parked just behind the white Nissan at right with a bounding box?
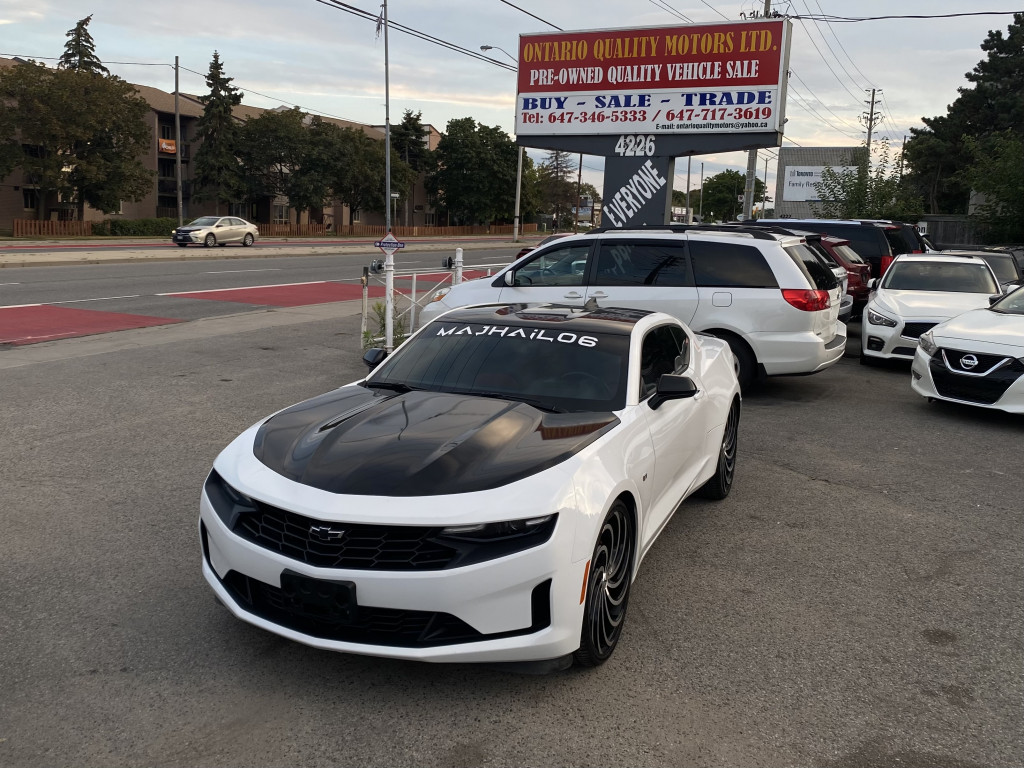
[860,253,1001,364]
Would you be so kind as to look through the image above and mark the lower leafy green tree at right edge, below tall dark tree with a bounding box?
[967,130,1024,243]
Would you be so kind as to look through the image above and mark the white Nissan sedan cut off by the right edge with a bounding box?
[910,288,1024,414]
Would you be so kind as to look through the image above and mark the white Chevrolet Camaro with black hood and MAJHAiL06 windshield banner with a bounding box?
[200,304,740,666]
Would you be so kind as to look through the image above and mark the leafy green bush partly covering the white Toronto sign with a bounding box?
[811,138,923,219]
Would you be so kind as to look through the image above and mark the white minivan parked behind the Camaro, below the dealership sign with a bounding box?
[421,227,846,385]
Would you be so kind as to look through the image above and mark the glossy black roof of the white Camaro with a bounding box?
[433,304,651,335]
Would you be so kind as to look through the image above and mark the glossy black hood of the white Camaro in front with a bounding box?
[253,386,618,497]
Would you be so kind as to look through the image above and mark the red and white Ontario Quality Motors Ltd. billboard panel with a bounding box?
[516,18,791,137]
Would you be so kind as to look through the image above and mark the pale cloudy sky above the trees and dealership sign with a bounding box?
[0,0,1020,204]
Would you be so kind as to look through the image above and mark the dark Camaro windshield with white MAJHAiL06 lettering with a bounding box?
[367,321,630,412]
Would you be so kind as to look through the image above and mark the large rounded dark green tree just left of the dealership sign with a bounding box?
[426,118,519,224]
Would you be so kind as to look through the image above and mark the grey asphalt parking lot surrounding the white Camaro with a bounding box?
[0,313,1024,768]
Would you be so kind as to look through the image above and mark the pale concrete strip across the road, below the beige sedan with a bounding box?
[0,234,545,268]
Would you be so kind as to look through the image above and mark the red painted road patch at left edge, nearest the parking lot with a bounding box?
[0,304,182,345]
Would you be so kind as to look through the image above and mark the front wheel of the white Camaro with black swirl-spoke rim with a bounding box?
[572,499,636,667]
